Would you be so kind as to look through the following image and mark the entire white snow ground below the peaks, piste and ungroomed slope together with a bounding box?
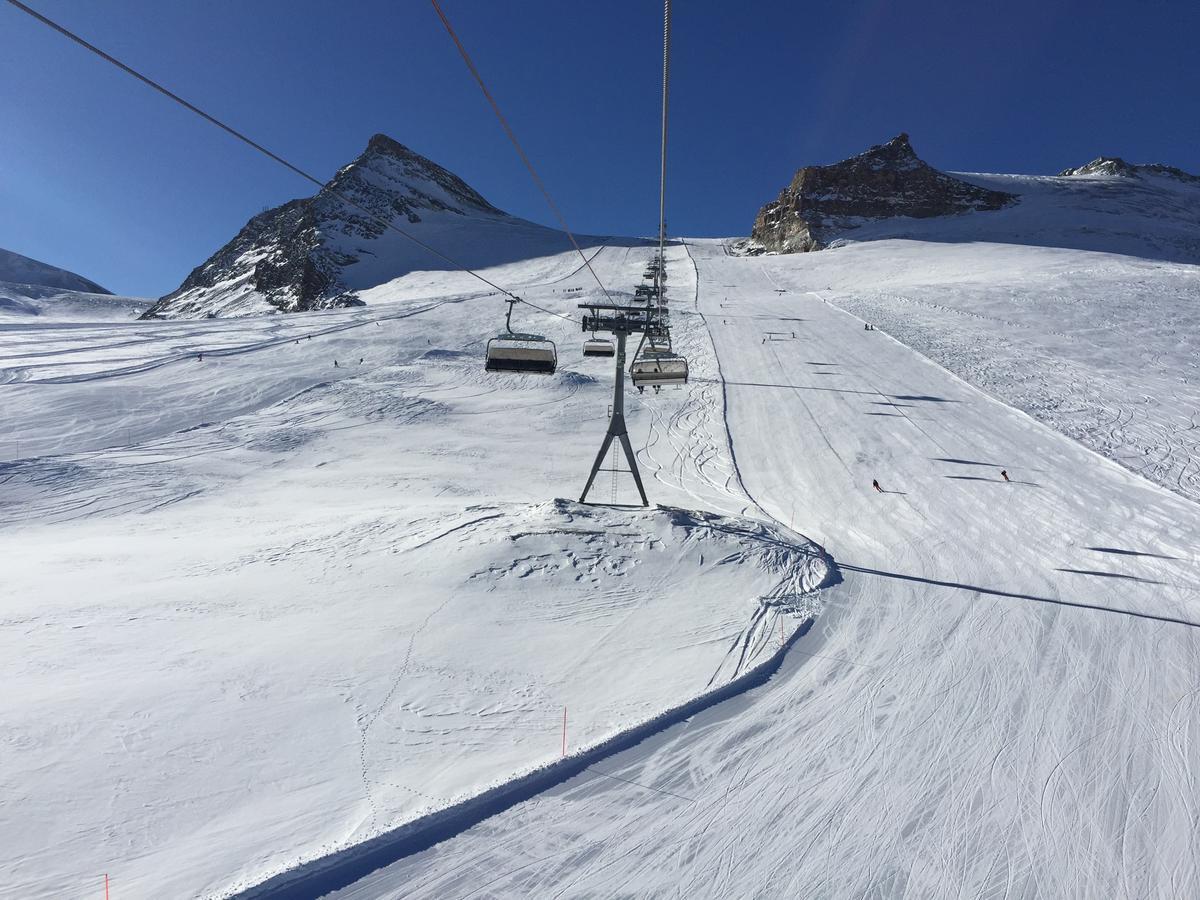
[0,170,1200,898]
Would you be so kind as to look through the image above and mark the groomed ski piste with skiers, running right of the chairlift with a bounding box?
[319,237,1200,900]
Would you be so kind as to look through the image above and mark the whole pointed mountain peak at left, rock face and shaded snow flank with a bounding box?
[146,134,609,318]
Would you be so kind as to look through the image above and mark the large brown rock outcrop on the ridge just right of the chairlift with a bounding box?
[750,134,1016,253]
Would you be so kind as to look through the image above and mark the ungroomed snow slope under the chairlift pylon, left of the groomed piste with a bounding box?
[0,247,827,898]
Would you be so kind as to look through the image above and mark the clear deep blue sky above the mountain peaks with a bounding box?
[0,0,1200,295]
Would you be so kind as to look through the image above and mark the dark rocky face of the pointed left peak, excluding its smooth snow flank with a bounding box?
[142,134,508,319]
